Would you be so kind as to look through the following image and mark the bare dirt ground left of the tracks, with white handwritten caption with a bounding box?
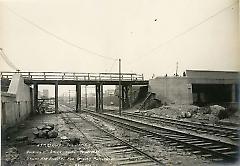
[1,114,108,166]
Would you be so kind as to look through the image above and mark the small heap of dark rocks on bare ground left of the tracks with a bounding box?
[33,123,58,138]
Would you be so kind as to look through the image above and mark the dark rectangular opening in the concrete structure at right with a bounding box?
[192,84,232,106]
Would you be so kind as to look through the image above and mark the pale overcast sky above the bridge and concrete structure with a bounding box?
[0,0,240,87]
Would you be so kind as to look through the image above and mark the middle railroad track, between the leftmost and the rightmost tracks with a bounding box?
[83,110,238,162]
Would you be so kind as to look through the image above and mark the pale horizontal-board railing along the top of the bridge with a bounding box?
[1,72,144,81]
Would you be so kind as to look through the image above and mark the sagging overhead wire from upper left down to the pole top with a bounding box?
[6,6,117,61]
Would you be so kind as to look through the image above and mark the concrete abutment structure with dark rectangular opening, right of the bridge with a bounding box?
[149,70,240,105]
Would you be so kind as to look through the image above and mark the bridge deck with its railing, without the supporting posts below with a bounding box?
[1,72,148,85]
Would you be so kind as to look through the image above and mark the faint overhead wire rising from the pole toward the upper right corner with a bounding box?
[130,0,238,65]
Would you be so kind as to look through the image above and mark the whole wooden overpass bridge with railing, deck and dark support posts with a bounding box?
[1,72,148,113]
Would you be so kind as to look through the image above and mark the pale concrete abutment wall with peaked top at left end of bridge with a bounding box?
[1,74,32,129]
